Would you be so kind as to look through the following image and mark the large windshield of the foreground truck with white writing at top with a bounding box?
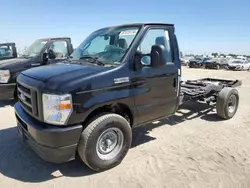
[71,27,139,65]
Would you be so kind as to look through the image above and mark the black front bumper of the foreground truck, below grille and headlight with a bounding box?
[14,103,82,163]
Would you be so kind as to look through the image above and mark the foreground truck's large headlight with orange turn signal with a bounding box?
[43,94,73,125]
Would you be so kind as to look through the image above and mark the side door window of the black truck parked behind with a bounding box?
[49,41,68,59]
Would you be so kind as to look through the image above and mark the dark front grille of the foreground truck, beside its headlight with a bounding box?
[17,82,39,118]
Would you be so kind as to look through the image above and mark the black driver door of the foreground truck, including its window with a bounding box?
[132,27,178,123]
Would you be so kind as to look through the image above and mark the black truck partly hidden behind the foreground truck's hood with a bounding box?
[0,37,73,100]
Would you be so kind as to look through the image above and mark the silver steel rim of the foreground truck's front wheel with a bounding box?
[96,128,124,160]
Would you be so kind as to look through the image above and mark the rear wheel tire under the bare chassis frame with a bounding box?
[216,87,239,120]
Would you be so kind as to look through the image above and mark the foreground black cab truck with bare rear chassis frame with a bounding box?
[14,23,242,171]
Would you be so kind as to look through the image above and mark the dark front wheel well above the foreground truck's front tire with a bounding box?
[83,103,133,127]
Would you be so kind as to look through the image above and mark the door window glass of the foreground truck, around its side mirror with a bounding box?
[137,29,174,65]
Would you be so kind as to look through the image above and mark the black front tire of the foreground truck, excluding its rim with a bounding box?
[78,113,132,172]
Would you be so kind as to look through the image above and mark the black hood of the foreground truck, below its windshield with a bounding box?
[22,63,110,85]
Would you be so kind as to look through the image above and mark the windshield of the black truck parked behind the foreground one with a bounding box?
[23,40,47,57]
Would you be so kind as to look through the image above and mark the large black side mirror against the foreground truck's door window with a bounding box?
[150,45,166,68]
